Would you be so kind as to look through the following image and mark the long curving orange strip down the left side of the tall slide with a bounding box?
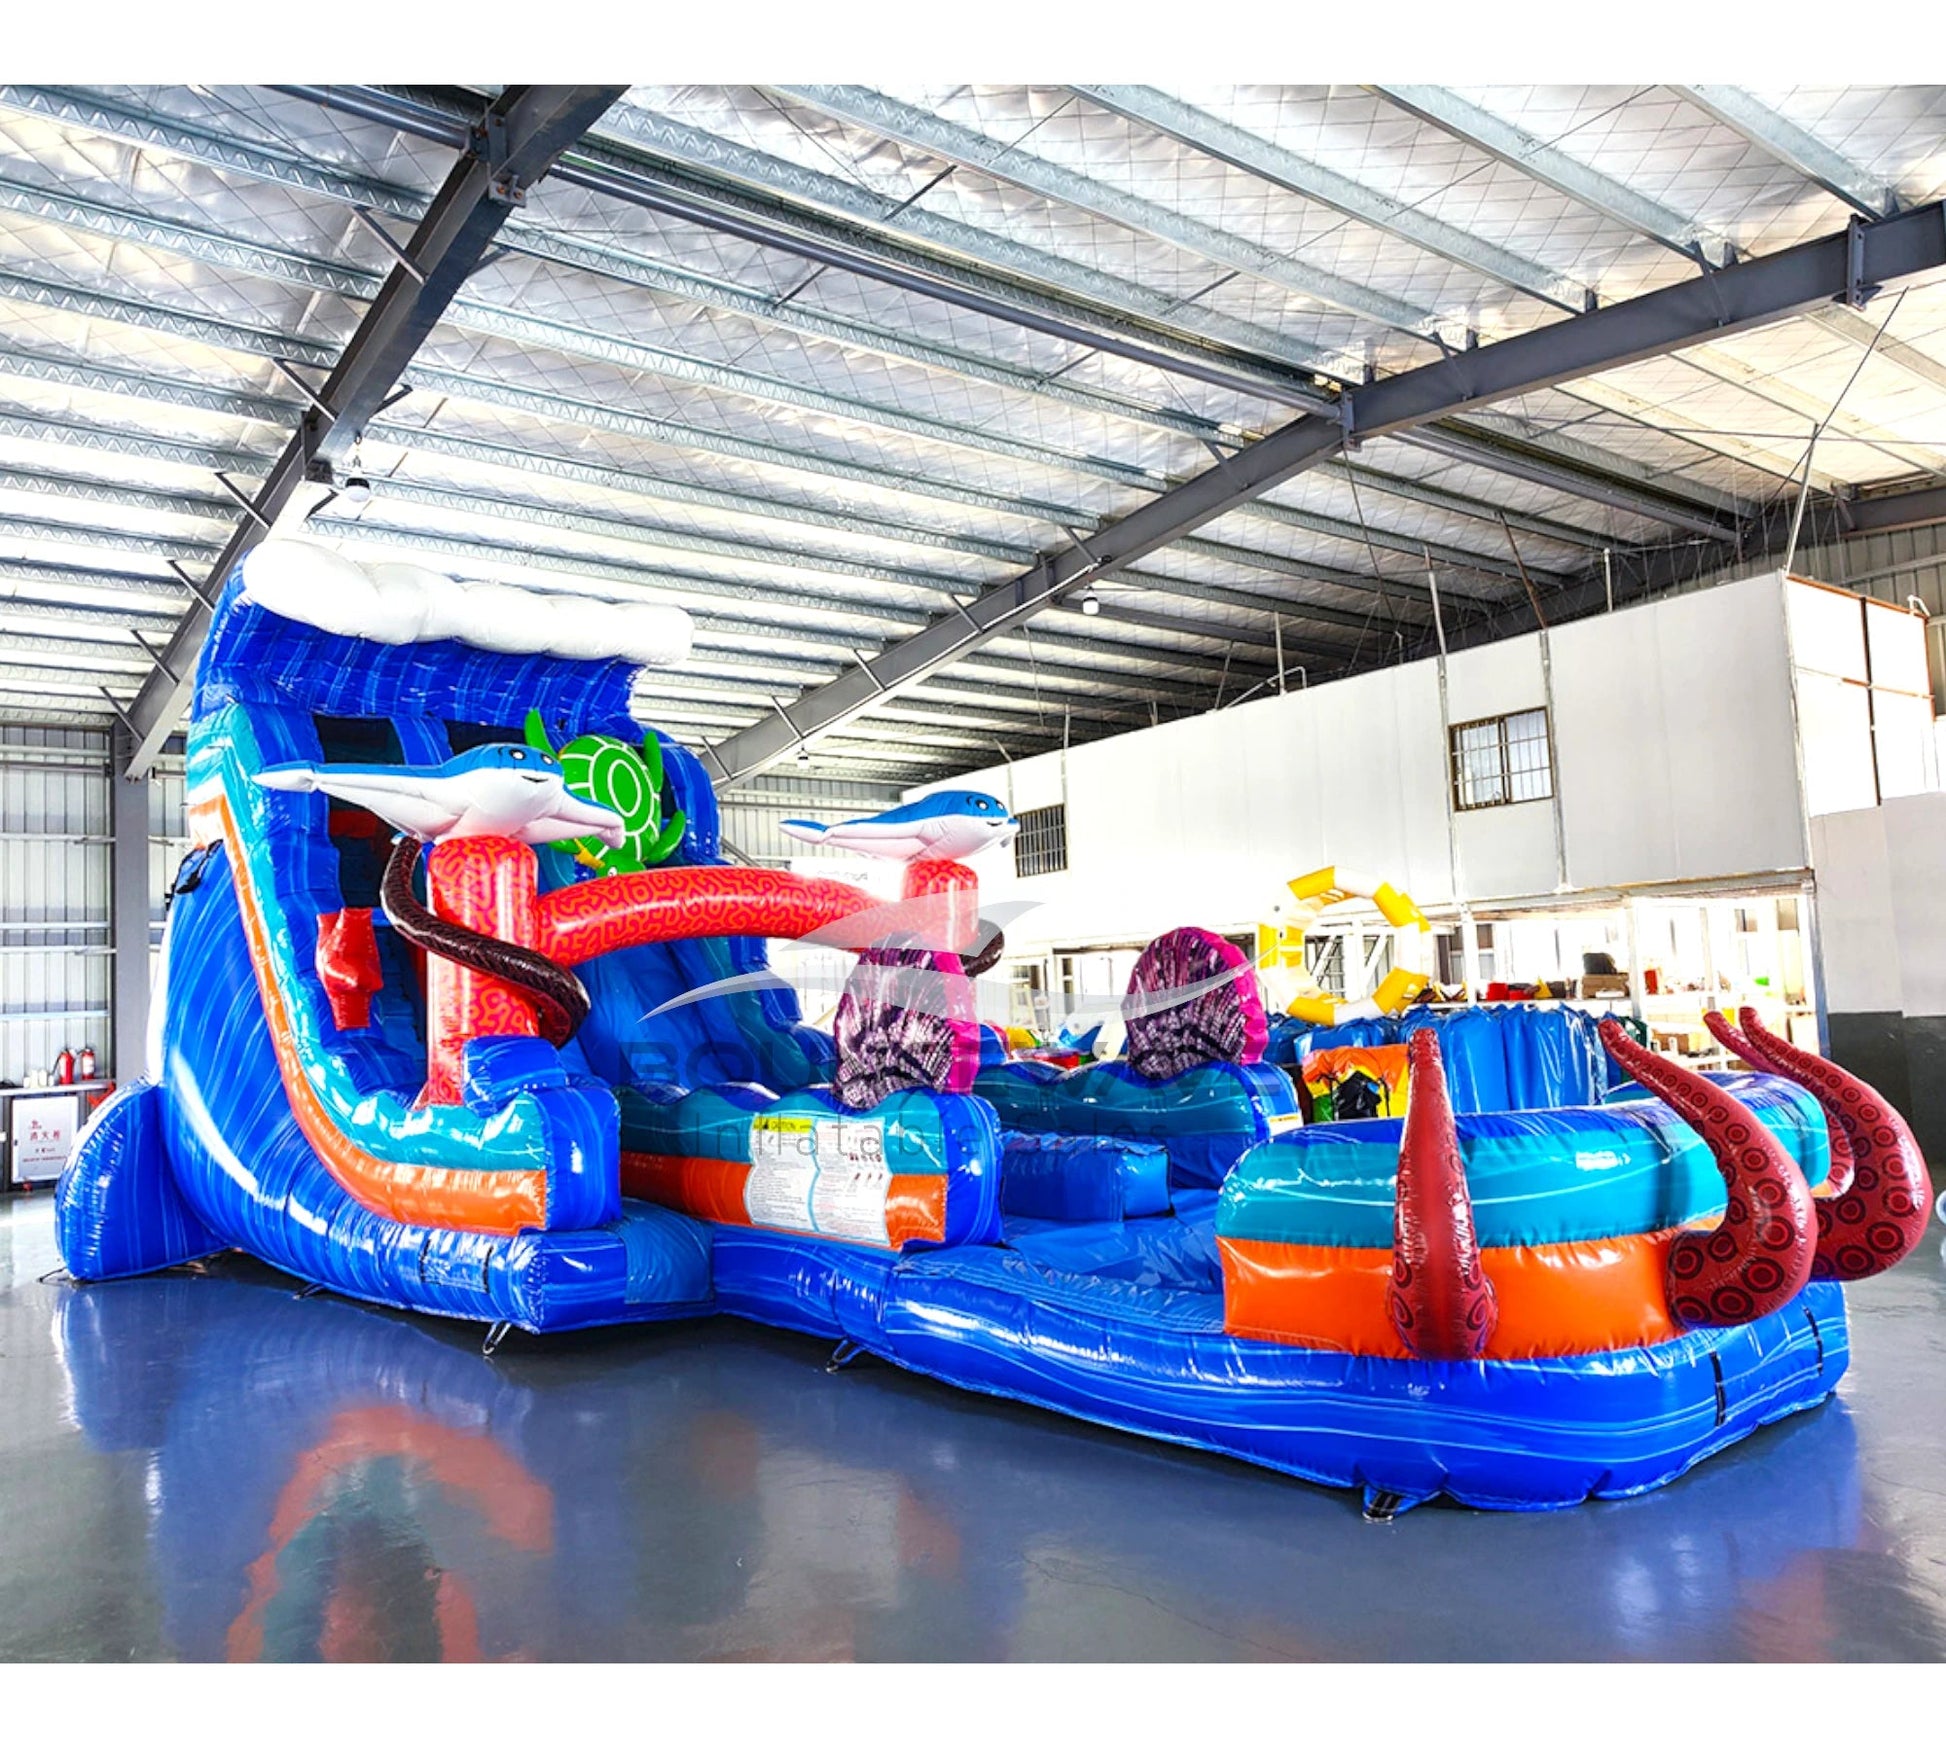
[208,792,547,1233]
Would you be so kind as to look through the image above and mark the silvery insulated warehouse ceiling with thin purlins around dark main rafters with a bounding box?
[0,84,1946,782]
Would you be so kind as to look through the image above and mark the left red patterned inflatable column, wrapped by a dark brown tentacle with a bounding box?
[418,839,539,1105]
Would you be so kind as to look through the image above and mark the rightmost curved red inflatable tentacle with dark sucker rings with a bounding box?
[1738,1010,1932,1282]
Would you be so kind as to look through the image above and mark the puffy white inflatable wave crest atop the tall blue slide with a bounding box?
[243,539,693,667]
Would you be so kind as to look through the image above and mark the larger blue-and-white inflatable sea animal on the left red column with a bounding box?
[257,741,627,846]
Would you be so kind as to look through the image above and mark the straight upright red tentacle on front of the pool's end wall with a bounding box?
[1387,1027,1500,1362]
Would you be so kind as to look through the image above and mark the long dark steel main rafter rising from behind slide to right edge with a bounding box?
[710,194,1946,780]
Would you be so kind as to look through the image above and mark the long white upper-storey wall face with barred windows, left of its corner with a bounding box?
[907,572,1808,953]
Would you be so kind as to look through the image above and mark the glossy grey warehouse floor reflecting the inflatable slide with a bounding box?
[0,1197,1946,1660]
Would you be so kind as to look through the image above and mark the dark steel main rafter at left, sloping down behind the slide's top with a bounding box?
[113,86,623,776]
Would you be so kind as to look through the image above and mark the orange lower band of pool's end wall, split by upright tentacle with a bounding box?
[1216,1230,1681,1362]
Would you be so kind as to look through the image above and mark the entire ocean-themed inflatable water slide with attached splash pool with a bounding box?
[58,541,1930,1514]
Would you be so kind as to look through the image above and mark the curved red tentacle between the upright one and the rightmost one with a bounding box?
[1600,1021,1818,1325]
